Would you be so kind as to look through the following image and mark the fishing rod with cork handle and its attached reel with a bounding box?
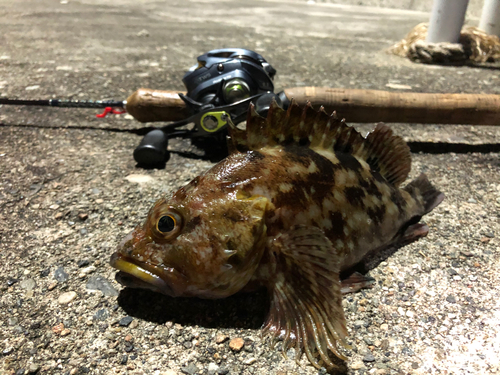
[0,48,500,167]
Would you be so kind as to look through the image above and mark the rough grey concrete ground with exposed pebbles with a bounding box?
[0,0,500,375]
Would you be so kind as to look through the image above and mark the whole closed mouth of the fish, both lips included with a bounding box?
[109,253,185,297]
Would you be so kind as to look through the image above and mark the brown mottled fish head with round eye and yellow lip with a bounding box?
[110,181,267,298]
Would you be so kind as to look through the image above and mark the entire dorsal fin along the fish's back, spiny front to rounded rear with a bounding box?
[229,99,411,186]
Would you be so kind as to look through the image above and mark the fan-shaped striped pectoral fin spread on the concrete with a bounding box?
[264,226,349,368]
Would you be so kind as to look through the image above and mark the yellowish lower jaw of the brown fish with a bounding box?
[110,253,182,297]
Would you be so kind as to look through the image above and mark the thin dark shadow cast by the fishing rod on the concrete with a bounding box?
[0,122,500,154]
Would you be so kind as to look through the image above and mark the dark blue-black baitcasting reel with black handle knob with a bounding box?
[134,48,288,167]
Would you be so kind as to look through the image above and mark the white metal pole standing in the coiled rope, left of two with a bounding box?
[426,0,469,43]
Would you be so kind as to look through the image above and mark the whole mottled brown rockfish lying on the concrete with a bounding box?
[111,102,444,367]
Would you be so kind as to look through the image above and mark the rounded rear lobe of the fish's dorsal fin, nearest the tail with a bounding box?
[356,123,411,187]
